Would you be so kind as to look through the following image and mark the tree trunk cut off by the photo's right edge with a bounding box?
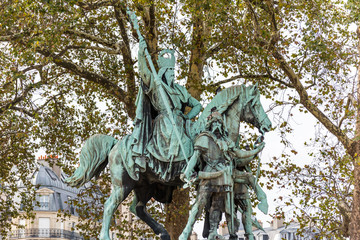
[350,24,360,240]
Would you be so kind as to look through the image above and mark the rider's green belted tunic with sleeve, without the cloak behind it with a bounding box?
[144,81,197,162]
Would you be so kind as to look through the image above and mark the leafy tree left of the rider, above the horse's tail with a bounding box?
[0,1,207,238]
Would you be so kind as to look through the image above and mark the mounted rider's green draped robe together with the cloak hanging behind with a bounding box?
[117,78,200,181]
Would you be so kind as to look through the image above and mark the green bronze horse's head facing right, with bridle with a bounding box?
[241,84,271,134]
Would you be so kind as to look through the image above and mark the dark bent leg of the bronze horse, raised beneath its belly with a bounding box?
[130,188,170,240]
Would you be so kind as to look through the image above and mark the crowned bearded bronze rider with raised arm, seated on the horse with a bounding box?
[127,40,202,181]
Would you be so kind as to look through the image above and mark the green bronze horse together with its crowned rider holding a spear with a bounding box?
[66,7,271,240]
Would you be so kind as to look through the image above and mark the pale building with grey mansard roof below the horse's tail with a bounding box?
[10,164,83,240]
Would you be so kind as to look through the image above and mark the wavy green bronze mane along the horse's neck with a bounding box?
[194,85,246,138]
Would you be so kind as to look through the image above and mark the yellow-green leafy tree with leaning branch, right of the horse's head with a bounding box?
[236,1,359,239]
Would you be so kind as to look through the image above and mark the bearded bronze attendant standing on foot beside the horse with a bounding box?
[179,111,265,240]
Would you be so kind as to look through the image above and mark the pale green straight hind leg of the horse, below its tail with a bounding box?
[100,185,132,240]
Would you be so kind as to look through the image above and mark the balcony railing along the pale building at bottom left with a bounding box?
[10,228,84,240]
